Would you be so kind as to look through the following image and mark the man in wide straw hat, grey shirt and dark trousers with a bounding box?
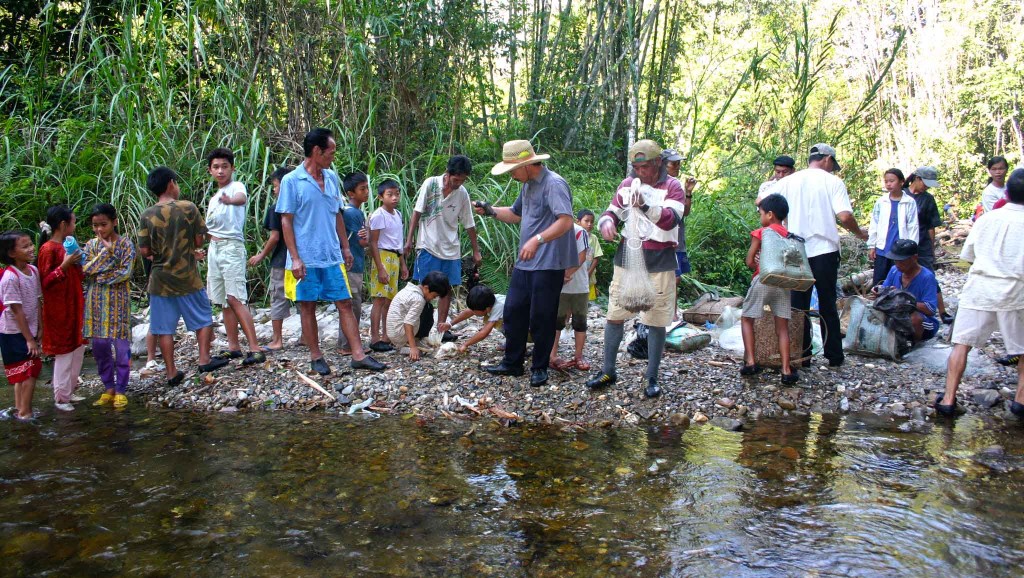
[476,140,580,386]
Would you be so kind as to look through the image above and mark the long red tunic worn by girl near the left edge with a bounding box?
[36,241,85,356]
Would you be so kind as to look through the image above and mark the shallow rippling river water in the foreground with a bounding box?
[0,388,1024,578]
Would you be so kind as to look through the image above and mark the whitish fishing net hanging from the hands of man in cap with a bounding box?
[618,178,657,313]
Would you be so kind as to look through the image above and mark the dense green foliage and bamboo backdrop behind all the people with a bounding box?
[0,0,1024,303]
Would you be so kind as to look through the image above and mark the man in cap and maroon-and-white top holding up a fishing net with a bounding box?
[587,139,685,398]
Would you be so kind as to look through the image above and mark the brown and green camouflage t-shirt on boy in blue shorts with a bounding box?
[138,200,206,297]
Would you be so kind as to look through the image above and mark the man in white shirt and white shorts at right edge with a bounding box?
[935,169,1024,417]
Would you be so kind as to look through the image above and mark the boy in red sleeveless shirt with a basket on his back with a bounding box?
[739,194,800,384]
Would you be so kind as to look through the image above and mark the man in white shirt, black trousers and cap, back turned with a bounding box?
[772,142,867,367]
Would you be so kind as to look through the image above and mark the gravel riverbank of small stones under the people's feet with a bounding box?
[83,257,1016,428]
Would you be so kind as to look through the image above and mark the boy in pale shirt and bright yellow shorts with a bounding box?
[368,178,409,353]
